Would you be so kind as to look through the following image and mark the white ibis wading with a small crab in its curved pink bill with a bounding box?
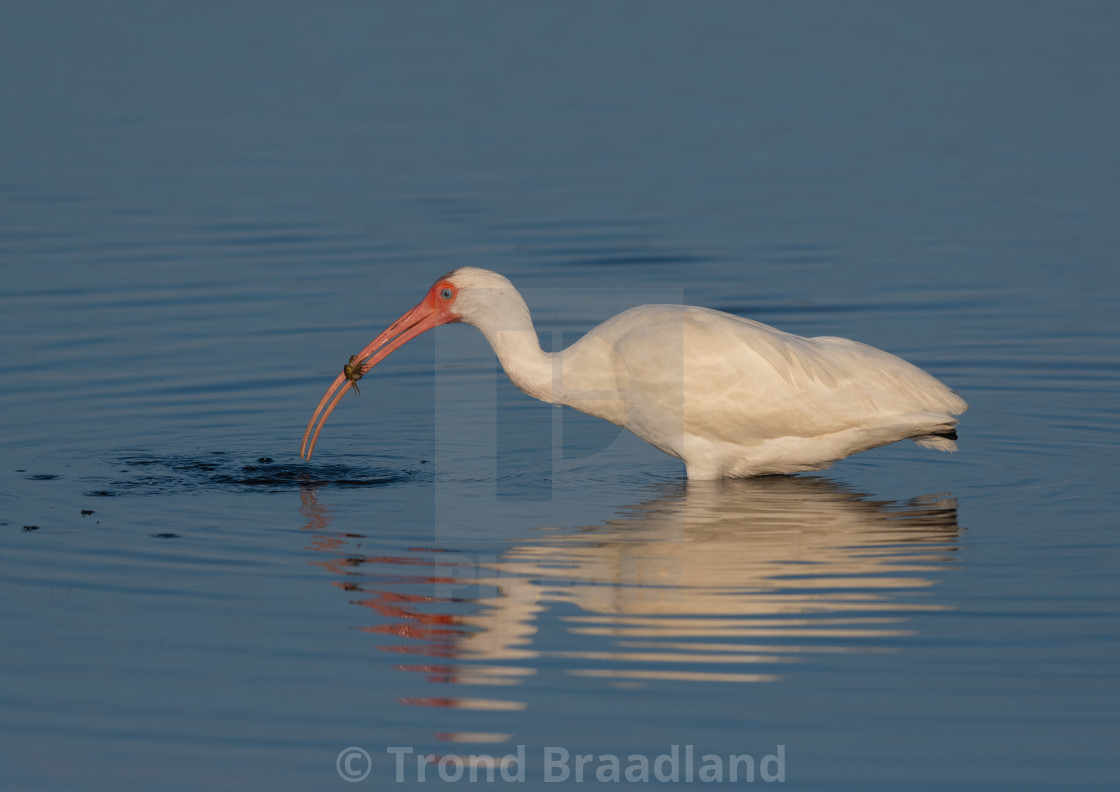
[300,267,968,478]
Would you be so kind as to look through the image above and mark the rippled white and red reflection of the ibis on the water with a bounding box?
[302,476,960,710]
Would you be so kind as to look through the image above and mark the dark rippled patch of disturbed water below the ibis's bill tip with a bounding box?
[85,451,417,497]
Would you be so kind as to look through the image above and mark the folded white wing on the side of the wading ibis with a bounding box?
[589,306,967,450]
